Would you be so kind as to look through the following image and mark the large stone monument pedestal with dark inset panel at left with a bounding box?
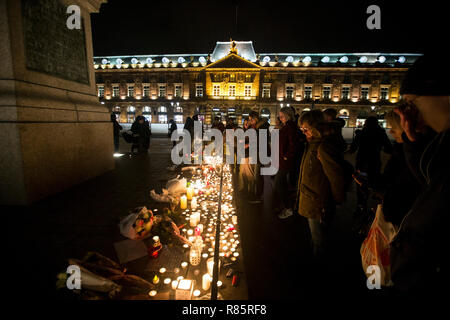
[0,0,114,205]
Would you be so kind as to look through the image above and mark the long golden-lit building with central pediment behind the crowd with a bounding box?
[94,41,420,127]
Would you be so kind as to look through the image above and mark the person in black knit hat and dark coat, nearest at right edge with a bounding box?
[390,55,450,297]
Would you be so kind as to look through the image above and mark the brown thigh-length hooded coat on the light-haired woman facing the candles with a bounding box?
[297,136,345,219]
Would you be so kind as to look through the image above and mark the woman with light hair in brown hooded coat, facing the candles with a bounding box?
[297,110,345,261]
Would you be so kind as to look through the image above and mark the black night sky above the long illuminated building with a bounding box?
[91,0,444,56]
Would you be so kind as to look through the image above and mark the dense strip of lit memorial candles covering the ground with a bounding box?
[149,164,240,297]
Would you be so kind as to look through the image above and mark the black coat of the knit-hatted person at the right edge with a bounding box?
[390,131,450,294]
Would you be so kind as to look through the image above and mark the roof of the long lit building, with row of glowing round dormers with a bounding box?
[94,41,421,69]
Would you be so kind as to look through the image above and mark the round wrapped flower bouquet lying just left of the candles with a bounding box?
[119,206,154,240]
